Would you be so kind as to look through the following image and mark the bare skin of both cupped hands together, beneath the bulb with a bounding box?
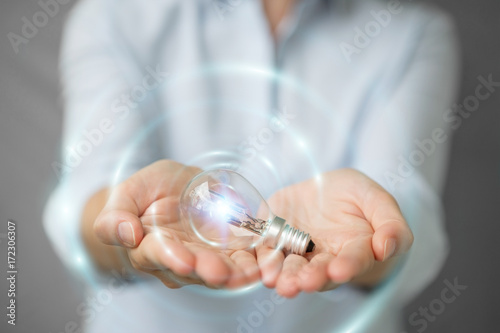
[82,160,413,297]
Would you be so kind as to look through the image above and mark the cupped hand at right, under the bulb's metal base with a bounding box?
[257,169,413,297]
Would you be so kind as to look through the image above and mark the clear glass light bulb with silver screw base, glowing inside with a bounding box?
[180,169,315,255]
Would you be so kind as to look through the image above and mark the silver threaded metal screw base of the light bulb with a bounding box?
[264,216,315,256]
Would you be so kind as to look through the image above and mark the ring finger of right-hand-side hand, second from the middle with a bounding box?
[276,254,308,297]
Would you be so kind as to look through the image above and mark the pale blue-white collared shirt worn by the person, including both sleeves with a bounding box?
[45,0,458,332]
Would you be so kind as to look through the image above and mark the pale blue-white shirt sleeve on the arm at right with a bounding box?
[352,6,460,302]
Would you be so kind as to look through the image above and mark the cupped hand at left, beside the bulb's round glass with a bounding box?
[94,160,260,288]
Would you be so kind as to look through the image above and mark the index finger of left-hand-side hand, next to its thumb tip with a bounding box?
[129,232,196,275]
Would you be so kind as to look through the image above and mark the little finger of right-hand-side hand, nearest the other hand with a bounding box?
[257,246,285,288]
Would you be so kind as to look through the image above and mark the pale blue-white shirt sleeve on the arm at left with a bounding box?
[44,0,164,274]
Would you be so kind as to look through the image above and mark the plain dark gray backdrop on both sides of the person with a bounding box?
[0,0,500,333]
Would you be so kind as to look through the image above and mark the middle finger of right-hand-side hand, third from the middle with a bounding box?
[299,253,335,292]
